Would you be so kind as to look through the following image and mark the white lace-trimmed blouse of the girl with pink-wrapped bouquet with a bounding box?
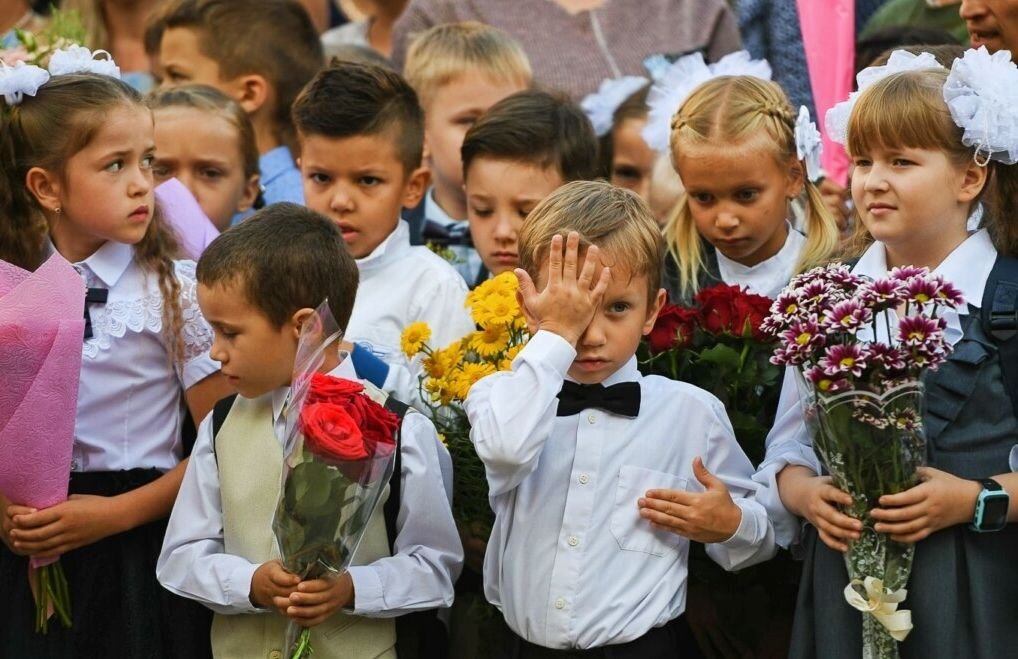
[71,240,219,472]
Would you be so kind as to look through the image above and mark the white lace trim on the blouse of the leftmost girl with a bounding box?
[81,261,212,370]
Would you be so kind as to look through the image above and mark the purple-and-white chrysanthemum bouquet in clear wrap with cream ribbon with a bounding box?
[765,264,963,659]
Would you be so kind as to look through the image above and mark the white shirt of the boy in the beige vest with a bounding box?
[156,360,463,617]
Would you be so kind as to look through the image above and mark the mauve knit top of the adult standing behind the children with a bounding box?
[392,0,741,100]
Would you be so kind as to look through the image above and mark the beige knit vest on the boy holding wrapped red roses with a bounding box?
[212,394,396,659]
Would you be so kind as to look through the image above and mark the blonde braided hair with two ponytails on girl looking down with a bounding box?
[665,75,838,295]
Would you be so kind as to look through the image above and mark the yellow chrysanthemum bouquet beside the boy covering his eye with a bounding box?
[401,272,530,539]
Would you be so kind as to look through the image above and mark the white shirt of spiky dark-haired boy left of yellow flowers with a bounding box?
[344,222,473,361]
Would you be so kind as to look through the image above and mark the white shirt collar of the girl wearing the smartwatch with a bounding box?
[852,229,997,314]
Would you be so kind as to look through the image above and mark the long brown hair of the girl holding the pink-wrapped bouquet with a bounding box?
[0,73,183,362]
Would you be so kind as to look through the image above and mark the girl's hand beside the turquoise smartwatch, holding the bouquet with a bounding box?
[870,466,982,542]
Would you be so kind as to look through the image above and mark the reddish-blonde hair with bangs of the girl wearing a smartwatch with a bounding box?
[846,68,1018,255]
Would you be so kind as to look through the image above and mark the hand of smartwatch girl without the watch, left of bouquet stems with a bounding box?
[778,464,862,553]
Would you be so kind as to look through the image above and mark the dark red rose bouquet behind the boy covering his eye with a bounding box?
[640,284,781,464]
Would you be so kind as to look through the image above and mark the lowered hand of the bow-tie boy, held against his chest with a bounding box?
[637,457,742,544]
